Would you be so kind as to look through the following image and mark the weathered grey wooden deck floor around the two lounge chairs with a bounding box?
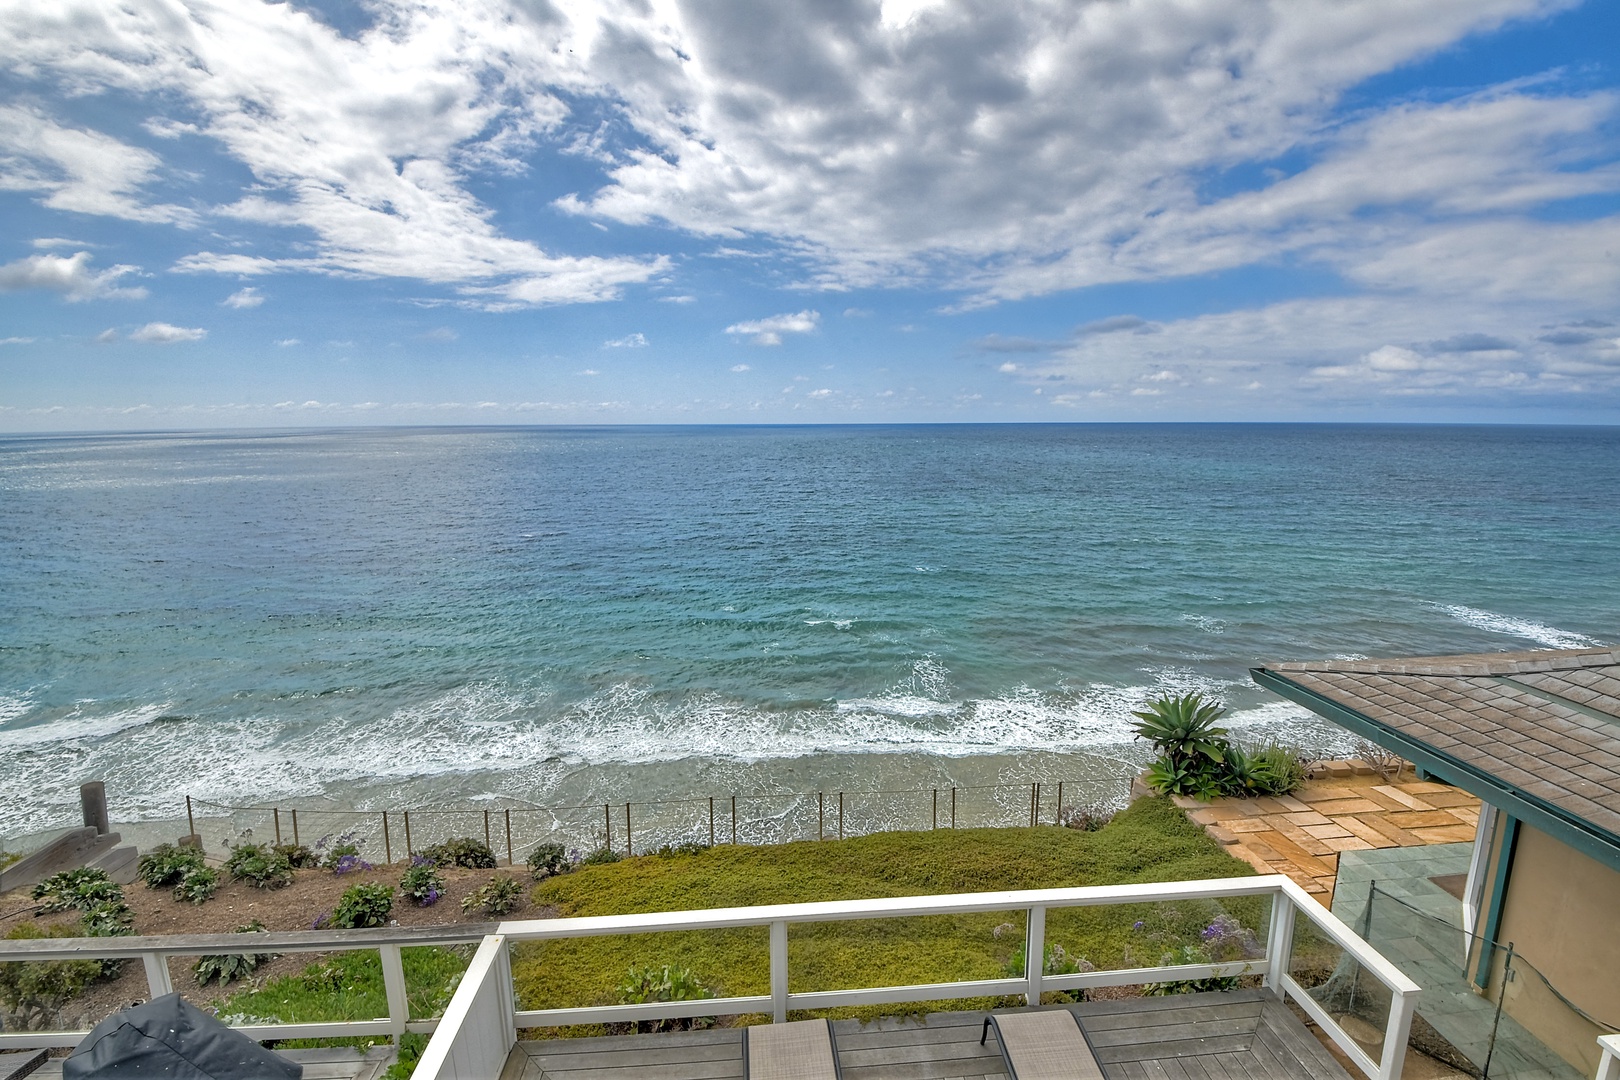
[501,989,1348,1080]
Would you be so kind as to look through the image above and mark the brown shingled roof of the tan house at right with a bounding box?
[1249,649,1620,865]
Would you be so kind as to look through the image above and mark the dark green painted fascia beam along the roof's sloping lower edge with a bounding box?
[1249,667,1620,871]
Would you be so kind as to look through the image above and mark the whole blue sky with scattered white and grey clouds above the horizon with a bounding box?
[0,0,1620,431]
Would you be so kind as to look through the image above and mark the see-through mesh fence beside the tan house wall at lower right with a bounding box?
[1349,882,1617,1080]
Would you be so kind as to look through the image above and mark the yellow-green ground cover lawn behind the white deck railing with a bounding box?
[514,798,1268,1033]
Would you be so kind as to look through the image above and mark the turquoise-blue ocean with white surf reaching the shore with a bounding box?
[0,426,1620,836]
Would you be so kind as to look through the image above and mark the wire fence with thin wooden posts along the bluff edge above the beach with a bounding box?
[186,776,1131,863]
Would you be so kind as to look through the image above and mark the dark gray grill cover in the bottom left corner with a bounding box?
[62,994,303,1080]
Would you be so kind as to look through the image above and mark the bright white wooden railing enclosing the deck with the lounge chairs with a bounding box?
[415,876,1418,1080]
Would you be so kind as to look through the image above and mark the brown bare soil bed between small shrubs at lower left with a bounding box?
[0,863,556,1030]
